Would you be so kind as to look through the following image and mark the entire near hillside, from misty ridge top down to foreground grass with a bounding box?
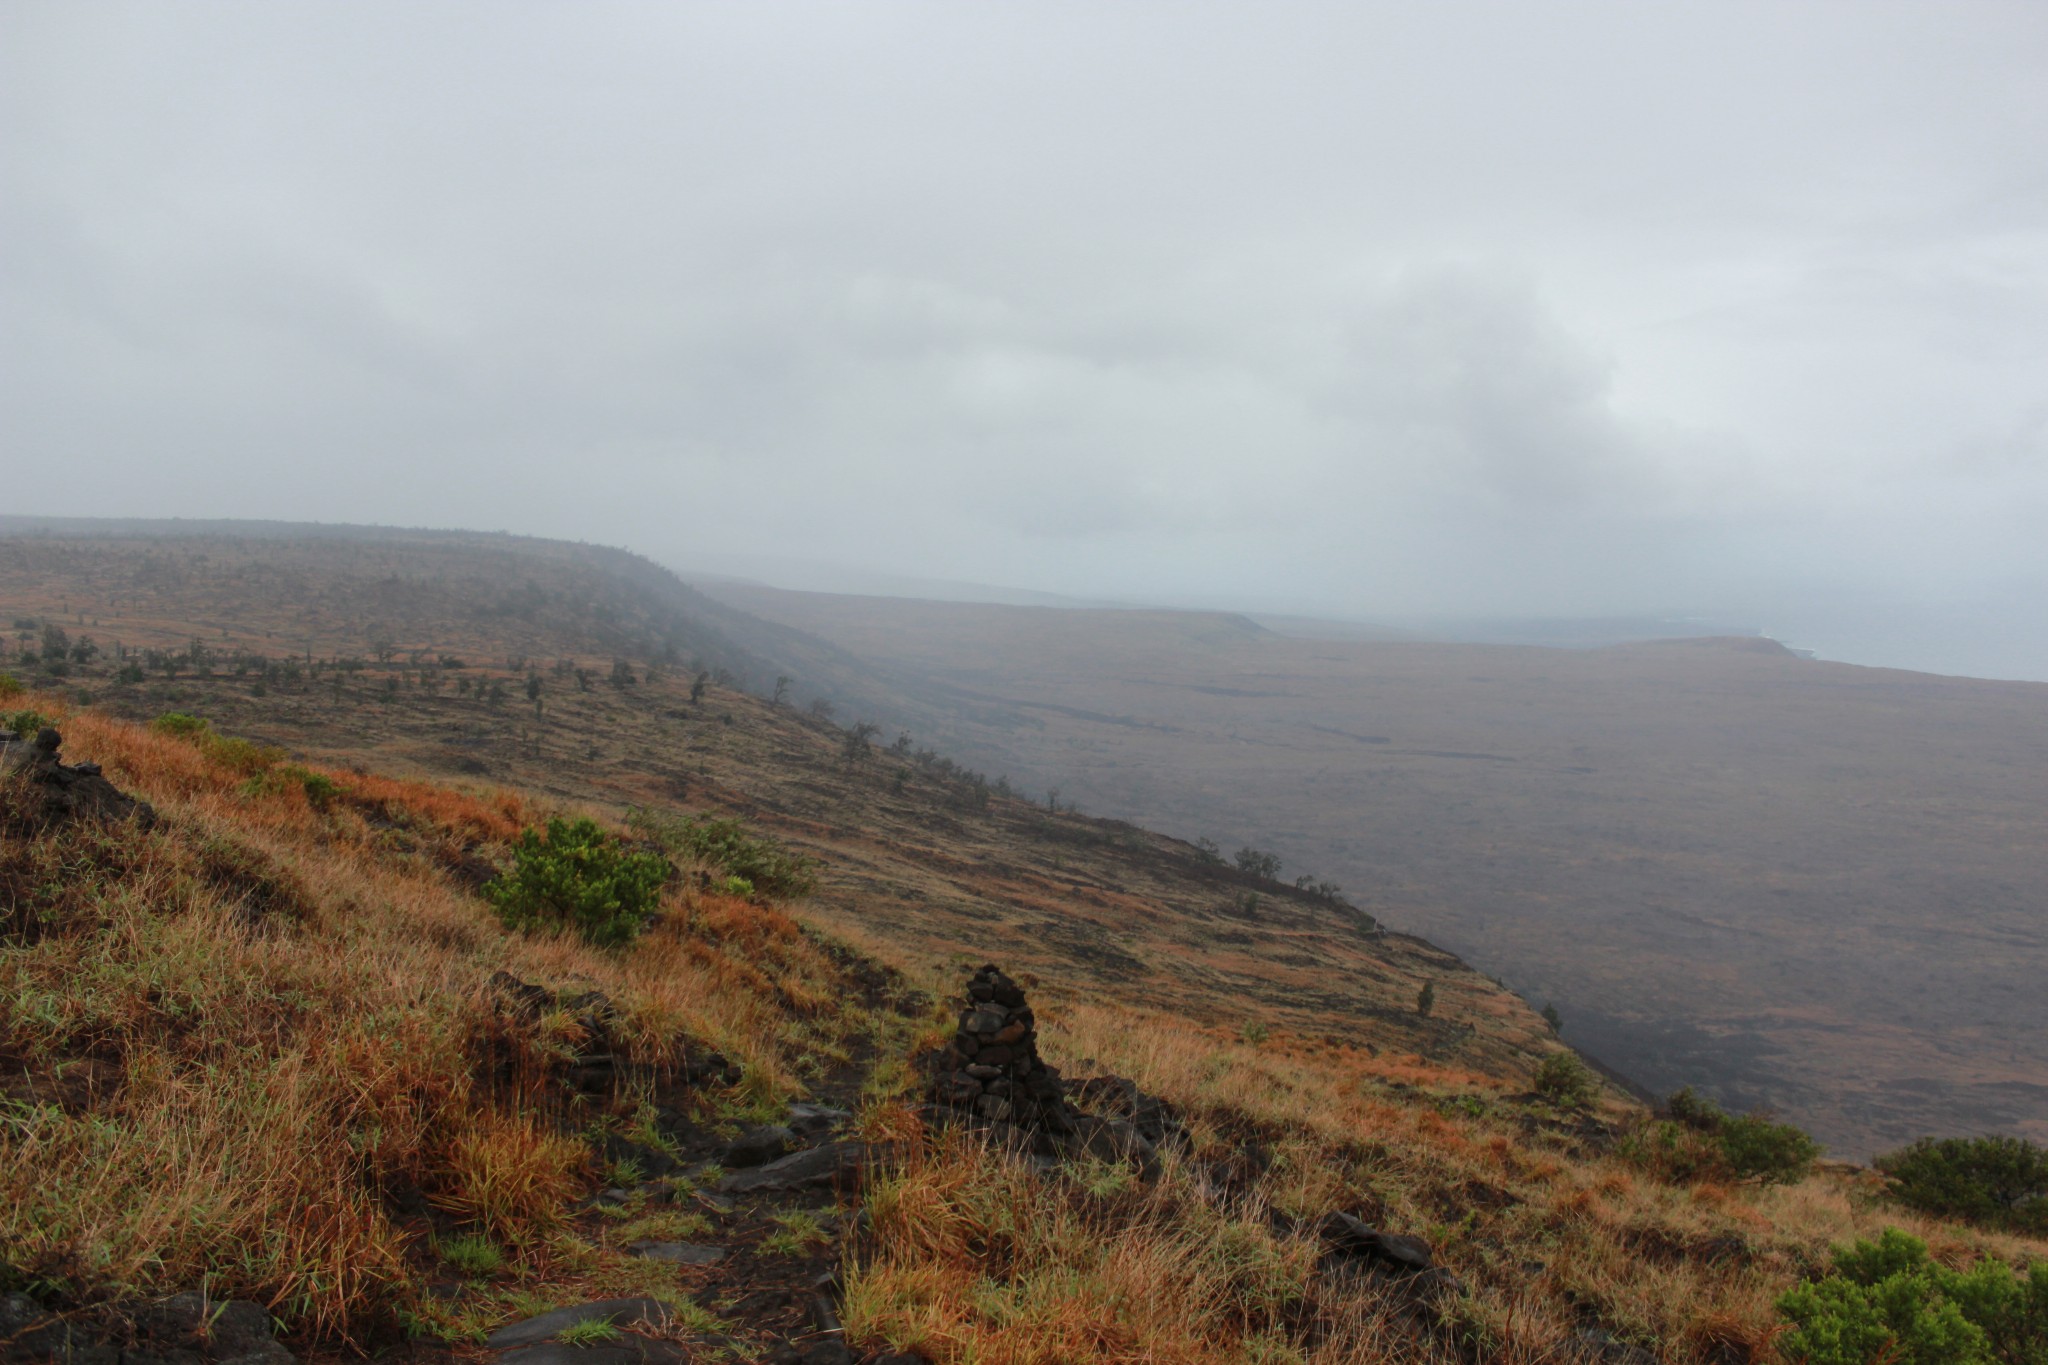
[0,536,2048,1365]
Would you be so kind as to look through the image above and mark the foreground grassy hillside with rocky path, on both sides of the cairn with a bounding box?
[0,692,2048,1365]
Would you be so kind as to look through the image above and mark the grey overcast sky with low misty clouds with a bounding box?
[0,0,2048,677]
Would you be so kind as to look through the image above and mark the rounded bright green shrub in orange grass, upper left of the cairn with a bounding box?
[483,814,670,948]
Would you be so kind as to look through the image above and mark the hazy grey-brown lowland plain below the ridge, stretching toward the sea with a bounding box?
[696,585,2048,1154]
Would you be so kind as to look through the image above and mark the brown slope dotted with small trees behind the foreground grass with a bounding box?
[0,532,1552,1074]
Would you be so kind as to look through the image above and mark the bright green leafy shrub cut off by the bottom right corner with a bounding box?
[1778,1228,2048,1365]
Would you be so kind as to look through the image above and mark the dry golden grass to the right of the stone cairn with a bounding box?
[850,1005,2048,1365]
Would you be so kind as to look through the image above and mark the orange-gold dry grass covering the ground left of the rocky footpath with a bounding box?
[0,696,872,1340]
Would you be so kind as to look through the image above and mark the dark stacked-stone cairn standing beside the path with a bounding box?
[932,964,1073,1134]
